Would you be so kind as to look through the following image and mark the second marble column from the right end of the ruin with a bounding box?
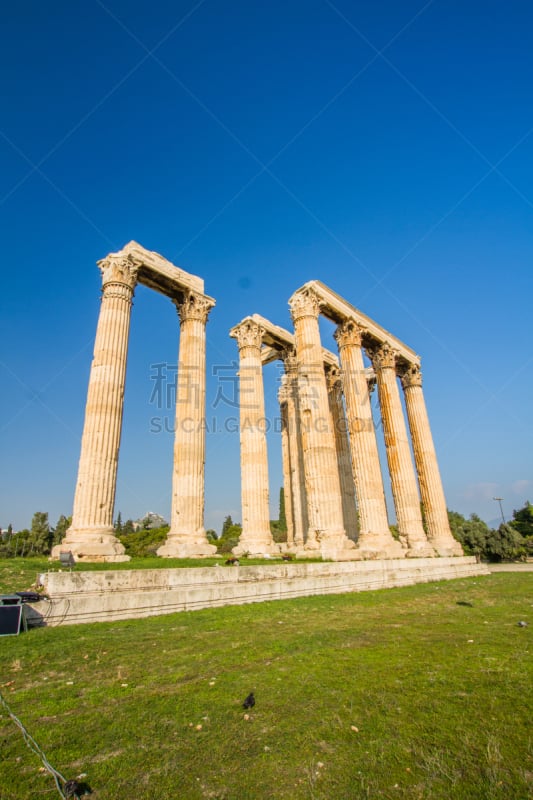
[367,343,435,558]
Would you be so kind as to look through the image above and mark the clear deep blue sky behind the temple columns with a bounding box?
[0,0,533,529]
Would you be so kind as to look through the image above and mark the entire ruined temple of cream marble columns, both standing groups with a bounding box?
[53,242,462,561]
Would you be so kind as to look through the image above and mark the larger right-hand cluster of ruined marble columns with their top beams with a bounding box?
[230,281,462,560]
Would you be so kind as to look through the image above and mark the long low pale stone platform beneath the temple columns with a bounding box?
[27,556,489,625]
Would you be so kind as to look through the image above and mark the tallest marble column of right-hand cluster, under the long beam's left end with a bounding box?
[289,289,355,559]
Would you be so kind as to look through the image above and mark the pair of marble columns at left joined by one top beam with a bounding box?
[52,242,216,561]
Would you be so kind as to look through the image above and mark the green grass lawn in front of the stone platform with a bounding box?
[0,573,533,800]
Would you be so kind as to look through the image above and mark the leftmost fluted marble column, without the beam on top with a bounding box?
[52,257,138,561]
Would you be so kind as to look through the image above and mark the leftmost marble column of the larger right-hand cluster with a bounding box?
[230,320,280,556]
